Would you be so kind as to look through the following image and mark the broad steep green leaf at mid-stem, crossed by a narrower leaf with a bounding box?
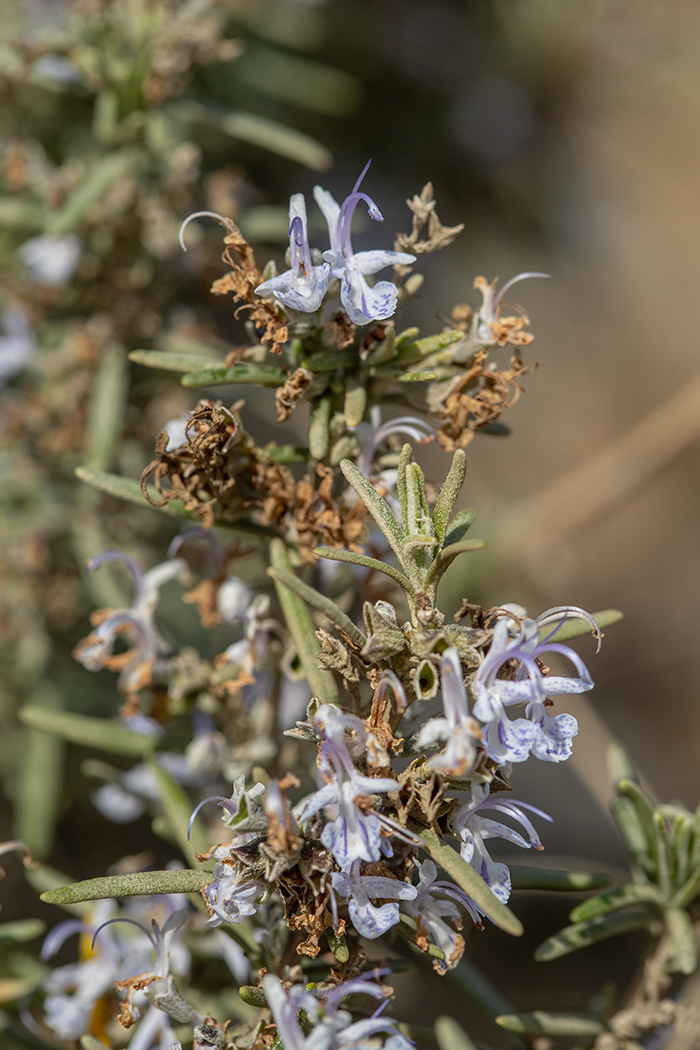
[268,540,340,704]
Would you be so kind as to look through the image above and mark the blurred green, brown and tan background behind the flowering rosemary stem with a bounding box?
[0,0,700,1040]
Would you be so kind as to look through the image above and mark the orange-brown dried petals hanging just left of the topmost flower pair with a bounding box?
[211,218,289,354]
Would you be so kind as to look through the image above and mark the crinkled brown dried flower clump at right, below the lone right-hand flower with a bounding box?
[438,349,537,452]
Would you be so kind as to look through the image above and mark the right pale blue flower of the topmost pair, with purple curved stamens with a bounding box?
[314,162,416,324]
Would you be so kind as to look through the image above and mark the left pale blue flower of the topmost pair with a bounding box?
[255,193,331,314]
